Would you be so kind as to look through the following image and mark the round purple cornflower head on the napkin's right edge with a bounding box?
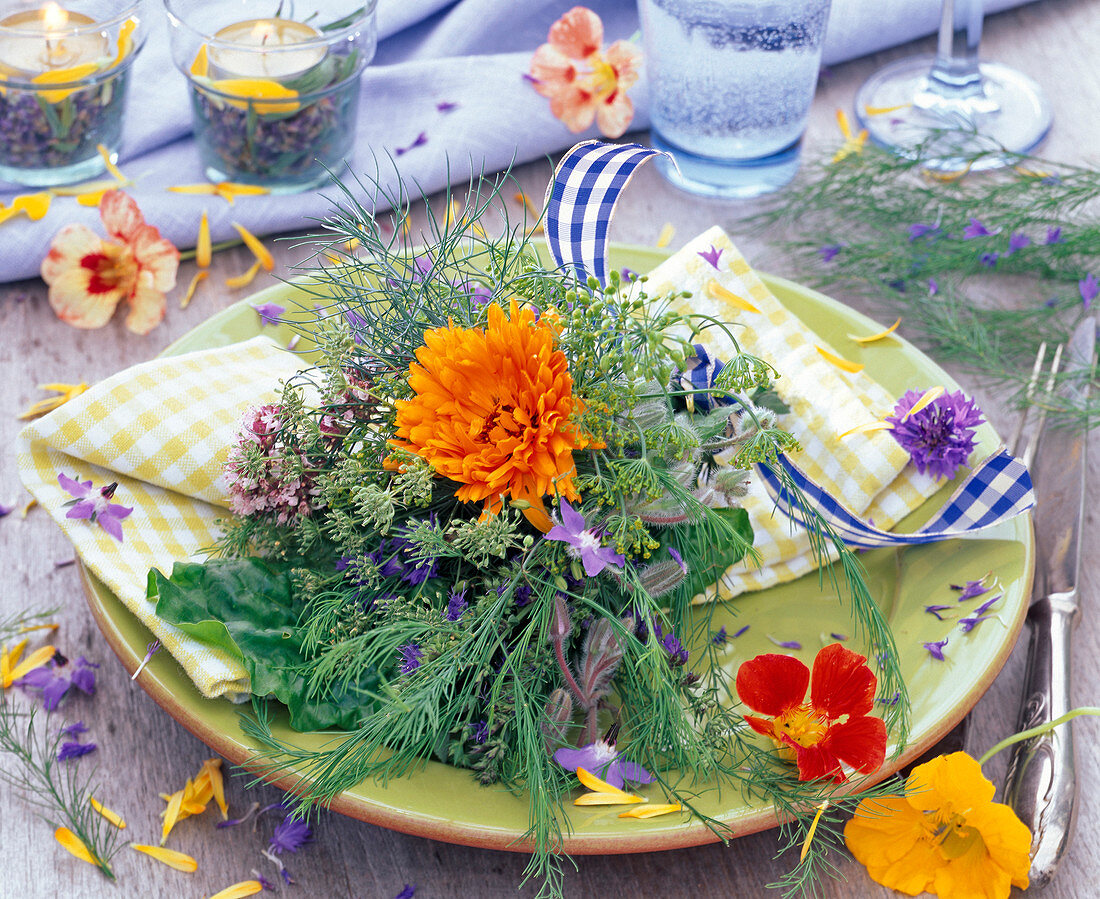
[886,391,985,479]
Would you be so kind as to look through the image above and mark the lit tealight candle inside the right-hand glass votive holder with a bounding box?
[209,19,326,80]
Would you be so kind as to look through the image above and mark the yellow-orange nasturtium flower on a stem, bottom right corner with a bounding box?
[844,753,1031,899]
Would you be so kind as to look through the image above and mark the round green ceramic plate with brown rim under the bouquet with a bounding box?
[77,246,1033,854]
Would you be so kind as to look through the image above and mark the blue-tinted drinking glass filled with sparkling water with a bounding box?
[638,0,829,197]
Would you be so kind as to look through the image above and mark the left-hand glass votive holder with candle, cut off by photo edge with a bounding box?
[0,0,149,187]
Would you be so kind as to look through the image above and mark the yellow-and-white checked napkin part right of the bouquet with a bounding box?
[646,228,936,599]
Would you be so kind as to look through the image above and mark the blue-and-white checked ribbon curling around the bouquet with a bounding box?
[546,141,1035,549]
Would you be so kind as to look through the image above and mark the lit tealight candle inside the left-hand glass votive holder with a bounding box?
[0,2,111,76]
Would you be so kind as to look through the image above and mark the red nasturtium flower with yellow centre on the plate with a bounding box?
[737,643,887,783]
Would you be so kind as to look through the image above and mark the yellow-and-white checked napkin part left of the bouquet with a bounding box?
[15,338,301,699]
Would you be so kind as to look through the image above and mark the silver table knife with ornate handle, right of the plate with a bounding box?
[1007,317,1097,887]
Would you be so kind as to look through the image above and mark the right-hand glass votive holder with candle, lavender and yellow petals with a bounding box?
[165,0,377,194]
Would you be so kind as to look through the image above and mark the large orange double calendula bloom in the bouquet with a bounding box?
[394,300,589,521]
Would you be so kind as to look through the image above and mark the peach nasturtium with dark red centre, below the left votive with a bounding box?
[42,190,179,335]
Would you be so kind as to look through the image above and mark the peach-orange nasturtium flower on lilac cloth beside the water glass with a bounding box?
[530,7,641,138]
